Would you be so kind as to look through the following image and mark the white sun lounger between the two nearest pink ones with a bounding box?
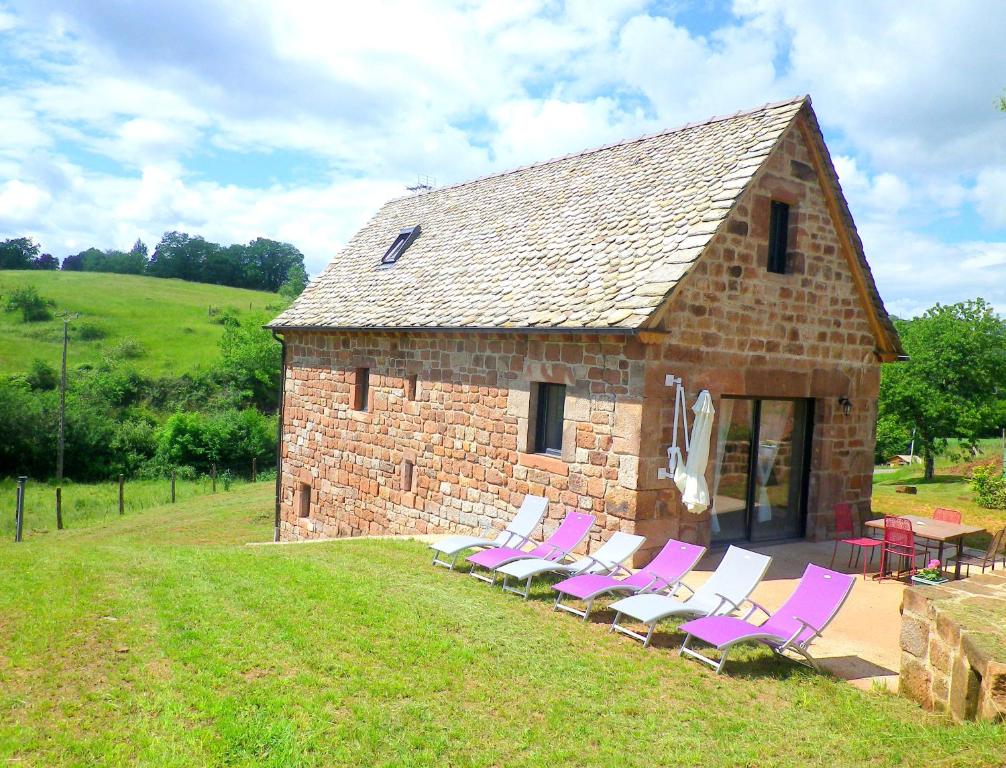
[610,547,772,647]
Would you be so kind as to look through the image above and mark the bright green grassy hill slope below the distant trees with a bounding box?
[0,271,284,375]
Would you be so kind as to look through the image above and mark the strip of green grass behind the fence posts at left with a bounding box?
[0,476,255,537]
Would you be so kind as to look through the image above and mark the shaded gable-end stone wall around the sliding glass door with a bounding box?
[640,114,880,542]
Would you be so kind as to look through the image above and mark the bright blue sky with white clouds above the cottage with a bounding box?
[0,0,1006,316]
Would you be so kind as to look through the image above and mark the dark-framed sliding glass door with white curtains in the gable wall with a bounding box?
[712,398,812,543]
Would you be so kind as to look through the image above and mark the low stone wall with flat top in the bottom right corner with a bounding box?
[899,572,1006,722]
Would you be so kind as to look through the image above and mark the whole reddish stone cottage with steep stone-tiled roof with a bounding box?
[271,98,901,560]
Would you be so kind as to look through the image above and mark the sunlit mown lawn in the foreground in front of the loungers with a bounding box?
[0,483,1006,768]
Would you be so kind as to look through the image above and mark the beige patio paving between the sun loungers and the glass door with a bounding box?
[686,542,905,690]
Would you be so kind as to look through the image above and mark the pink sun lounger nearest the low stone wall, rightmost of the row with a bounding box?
[679,564,856,673]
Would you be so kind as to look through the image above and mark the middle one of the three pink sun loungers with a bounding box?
[552,539,705,621]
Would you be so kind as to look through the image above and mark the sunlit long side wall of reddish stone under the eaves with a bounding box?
[281,332,644,543]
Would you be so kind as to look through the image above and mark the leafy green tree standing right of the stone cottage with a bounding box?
[880,299,1006,480]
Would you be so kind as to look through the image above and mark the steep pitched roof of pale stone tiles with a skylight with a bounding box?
[271,97,896,354]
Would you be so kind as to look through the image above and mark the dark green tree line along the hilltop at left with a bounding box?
[0,232,307,296]
